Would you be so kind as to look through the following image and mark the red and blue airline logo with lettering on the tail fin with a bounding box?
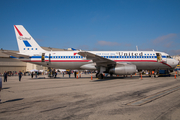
[14,25,32,47]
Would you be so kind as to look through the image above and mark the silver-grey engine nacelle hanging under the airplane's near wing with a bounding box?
[109,64,136,75]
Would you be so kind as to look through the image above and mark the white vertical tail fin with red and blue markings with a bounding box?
[14,25,45,53]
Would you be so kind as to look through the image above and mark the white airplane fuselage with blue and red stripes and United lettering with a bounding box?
[18,51,178,70]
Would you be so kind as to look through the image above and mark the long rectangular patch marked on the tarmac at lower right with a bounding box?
[127,86,180,106]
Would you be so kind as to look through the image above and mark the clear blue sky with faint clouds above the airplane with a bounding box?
[0,0,180,55]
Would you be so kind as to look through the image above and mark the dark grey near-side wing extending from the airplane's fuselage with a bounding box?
[78,51,116,66]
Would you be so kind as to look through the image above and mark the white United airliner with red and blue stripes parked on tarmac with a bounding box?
[4,25,179,79]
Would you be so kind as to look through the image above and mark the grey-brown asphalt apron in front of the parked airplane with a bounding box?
[0,75,180,120]
